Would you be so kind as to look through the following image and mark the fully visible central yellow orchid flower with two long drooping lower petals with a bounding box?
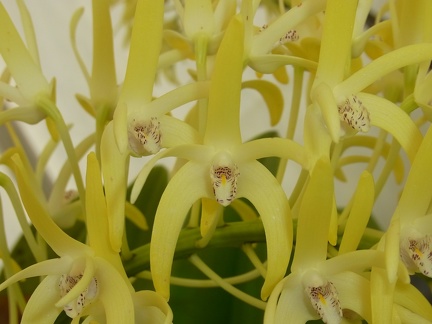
[126,13,309,299]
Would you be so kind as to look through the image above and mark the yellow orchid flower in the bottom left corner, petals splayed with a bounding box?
[0,154,172,323]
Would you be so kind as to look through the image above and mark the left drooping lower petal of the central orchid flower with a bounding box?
[150,162,213,299]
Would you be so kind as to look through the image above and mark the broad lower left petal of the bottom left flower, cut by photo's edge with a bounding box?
[21,275,63,324]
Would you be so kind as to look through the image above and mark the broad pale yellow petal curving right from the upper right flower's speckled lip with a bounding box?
[357,92,422,162]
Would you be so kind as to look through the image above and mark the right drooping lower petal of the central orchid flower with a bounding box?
[237,161,293,300]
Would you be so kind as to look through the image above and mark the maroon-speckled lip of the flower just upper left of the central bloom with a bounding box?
[128,117,162,155]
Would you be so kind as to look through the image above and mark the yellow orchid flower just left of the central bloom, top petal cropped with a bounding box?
[101,0,208,251]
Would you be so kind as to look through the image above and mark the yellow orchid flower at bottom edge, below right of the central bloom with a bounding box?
[264,158,384,323]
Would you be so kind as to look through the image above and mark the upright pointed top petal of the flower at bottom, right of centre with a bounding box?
[291,158,333,271]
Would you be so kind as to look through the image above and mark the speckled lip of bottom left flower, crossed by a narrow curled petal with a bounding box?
[59,273,98,318]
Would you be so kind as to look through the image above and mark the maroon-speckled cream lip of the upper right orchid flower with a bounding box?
[338,95,370,132]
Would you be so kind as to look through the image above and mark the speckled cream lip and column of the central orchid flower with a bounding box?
[210,156,240,206]
